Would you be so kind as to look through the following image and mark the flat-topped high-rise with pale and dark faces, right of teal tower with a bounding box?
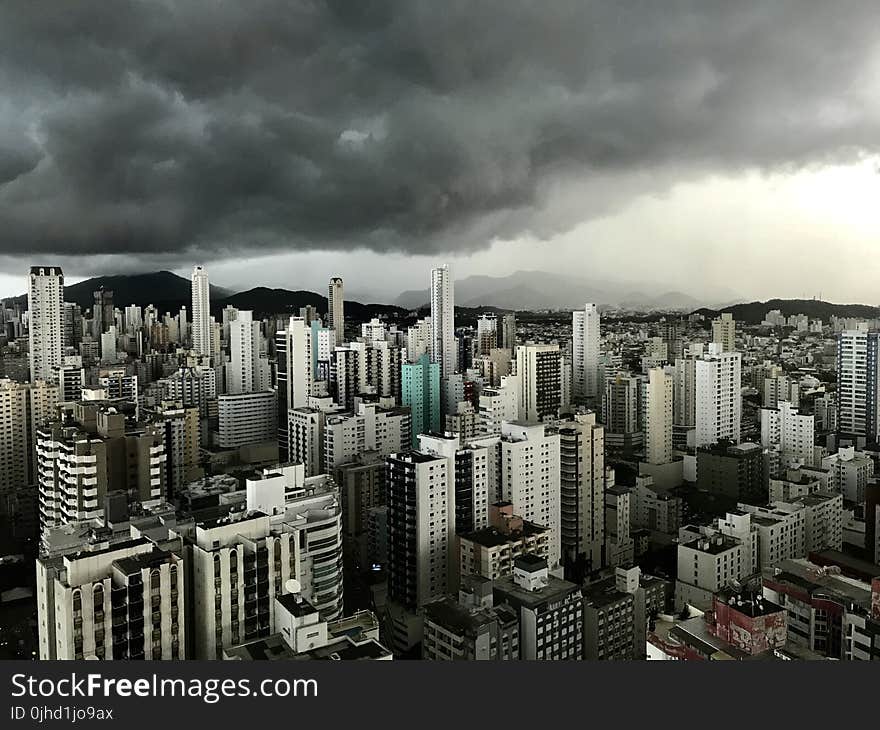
[516,343,562,423]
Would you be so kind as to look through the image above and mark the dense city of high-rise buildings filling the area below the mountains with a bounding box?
[0,266,880,661]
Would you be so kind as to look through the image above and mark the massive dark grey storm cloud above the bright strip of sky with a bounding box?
[0,0,880,260]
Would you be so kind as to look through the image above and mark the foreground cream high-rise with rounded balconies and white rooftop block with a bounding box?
[192,465,343,659]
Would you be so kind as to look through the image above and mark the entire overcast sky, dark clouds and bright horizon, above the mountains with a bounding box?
[0,0,880,304]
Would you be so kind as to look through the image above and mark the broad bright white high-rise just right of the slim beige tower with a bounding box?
[694,343,742,446]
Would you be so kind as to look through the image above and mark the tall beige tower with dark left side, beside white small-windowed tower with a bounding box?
[559,411,605,570]
